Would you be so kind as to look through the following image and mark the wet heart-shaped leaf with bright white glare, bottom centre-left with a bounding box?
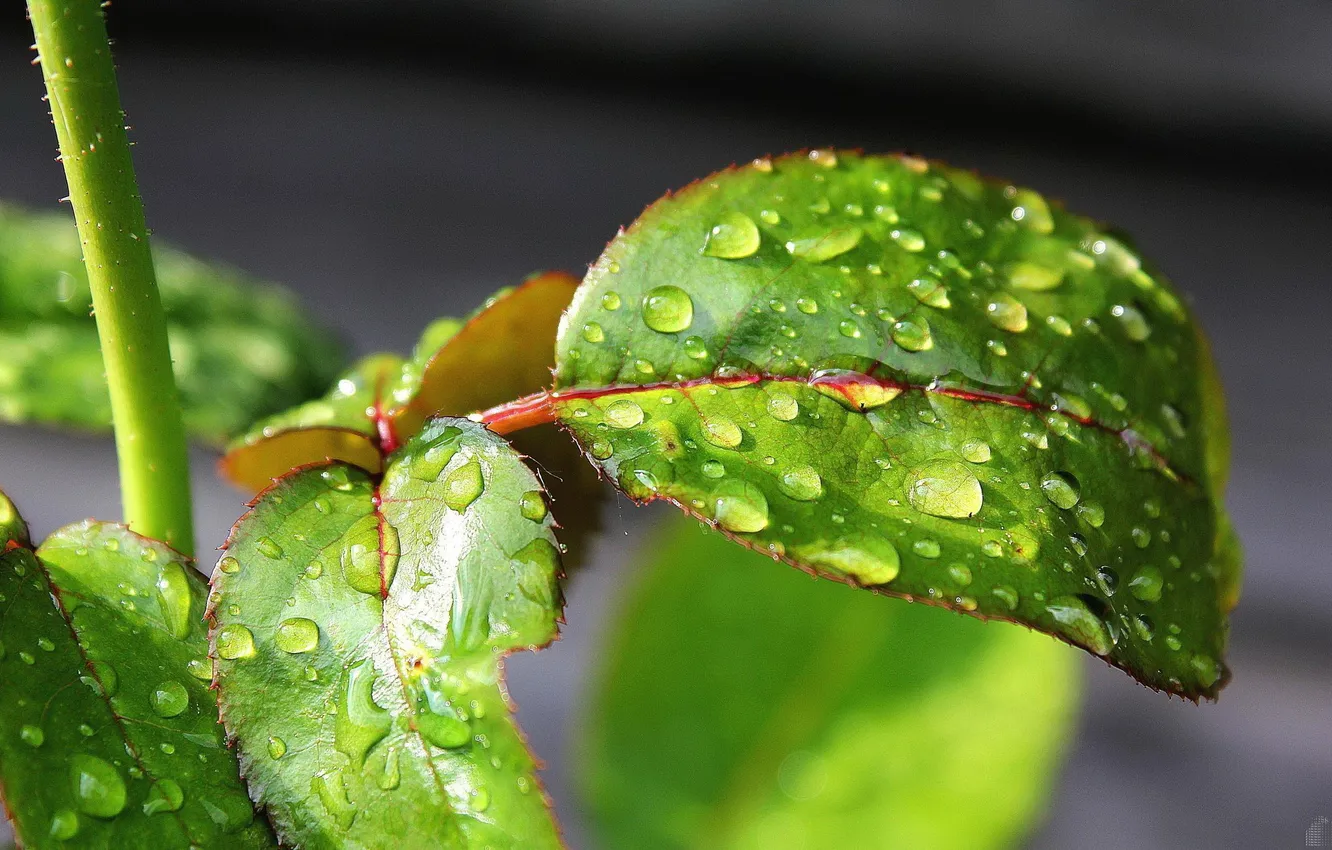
[210,420,562,847]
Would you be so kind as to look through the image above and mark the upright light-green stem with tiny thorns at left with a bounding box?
[28,0,193,554]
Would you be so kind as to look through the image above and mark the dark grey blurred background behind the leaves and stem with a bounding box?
[0,0,1332,850]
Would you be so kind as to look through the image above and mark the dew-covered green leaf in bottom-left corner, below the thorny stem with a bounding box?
[0,494,276,847]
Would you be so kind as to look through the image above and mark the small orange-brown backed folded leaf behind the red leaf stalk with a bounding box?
[221,272,578,492]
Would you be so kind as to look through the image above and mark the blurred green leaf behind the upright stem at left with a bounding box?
[0,205,345,444]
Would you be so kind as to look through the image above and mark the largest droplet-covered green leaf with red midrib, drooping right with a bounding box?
[553,151,1239,698]
